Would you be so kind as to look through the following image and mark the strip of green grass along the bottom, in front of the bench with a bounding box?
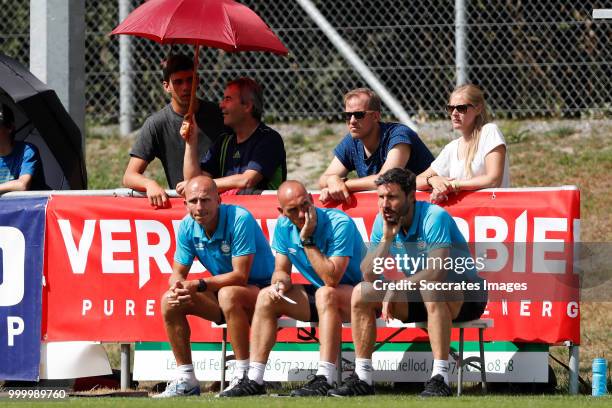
[0,394,612,408]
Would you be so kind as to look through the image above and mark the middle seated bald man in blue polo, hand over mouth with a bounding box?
[221,181,365,397]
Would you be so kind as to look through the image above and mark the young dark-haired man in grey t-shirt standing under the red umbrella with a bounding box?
[123,54,225,208]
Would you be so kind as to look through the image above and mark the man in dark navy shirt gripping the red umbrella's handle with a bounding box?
[181,78,287,194]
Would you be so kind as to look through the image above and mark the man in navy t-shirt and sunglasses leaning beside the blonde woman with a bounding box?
[319,88,434,202]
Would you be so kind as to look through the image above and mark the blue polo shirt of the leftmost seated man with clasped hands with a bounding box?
[174,204,274,286]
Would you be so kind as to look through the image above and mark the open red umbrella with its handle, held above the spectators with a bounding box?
[111,0,288,114]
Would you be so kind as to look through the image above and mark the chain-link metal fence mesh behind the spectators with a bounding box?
[0,0,612,127]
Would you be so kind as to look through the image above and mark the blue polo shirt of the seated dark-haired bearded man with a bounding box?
[370,201,481,281]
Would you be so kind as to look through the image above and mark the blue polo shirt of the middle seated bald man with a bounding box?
[272,208,366,288]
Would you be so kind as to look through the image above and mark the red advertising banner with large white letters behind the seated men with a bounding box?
[42,187,580,344]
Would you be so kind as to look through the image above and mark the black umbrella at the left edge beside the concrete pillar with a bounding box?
[0,53,87,190]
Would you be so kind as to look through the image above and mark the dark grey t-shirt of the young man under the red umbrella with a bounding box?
[130,100,228,188]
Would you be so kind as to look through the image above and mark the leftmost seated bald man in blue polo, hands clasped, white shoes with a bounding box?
[158,176,274,398]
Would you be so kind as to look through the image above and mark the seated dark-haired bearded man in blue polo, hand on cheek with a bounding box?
[328,169,487,397]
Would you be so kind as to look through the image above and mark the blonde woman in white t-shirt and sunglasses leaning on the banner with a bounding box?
[417,84,510,203]
